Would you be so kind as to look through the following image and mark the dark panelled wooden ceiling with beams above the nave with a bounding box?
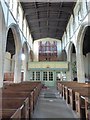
[21,1,76,40]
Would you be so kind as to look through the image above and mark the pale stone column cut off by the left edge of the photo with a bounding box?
[0,4,6,88]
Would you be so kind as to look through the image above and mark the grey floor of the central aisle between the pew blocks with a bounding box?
[32,87,76,118]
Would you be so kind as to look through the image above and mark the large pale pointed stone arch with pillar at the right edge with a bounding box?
[76,23,90,82]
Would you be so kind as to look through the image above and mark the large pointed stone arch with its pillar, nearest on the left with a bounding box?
[5,23,22,82]
